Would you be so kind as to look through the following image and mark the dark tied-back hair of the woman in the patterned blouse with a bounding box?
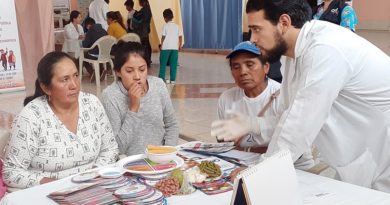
[23,51,74,106]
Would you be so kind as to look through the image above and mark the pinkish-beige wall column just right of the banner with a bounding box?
[15,0,54,95]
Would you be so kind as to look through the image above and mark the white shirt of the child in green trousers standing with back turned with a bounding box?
[161,21,183,50]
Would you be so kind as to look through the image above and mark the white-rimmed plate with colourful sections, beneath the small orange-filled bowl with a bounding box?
[117,154,184,175]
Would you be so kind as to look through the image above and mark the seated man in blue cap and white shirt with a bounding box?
[211,41,313,169]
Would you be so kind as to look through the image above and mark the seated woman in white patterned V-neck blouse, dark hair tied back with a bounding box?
[3,52,118,188]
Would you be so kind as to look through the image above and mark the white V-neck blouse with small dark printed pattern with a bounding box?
[3,92,118,188]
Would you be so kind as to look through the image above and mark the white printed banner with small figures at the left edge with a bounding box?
[0,0,24,93]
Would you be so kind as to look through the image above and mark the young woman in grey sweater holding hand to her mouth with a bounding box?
[102,41,179,155]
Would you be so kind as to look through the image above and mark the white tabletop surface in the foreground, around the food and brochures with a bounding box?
[0,170,390,205]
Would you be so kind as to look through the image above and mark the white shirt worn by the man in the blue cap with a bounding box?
[218,79,280,147]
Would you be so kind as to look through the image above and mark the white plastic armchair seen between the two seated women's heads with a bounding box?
[79,35,116,90]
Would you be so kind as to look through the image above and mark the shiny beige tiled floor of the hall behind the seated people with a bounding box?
[0,31,390,146]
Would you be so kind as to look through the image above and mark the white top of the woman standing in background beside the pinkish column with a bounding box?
[62,23,84,58]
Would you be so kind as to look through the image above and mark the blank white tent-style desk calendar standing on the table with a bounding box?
[230,150,302,205]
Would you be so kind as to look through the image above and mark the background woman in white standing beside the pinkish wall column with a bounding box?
[62,10,85,59]
